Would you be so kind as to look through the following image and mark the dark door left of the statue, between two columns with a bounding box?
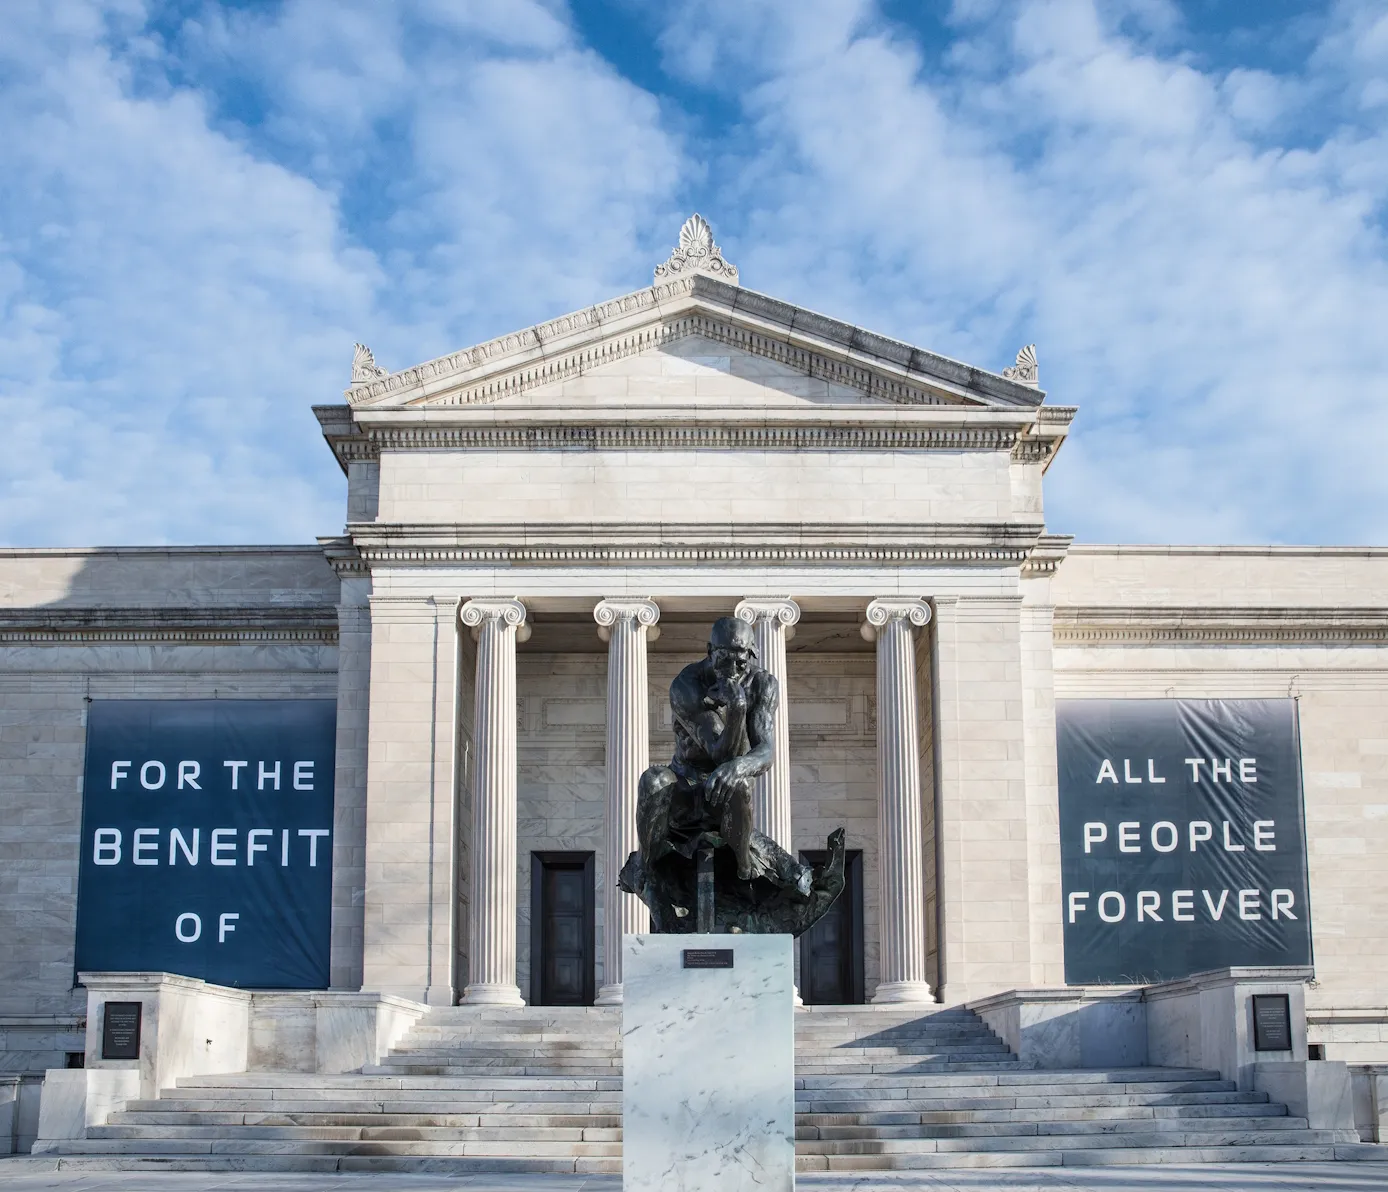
[530,852,594,1006]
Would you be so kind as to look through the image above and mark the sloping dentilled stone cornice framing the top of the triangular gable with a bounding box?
[346,273,1045,411]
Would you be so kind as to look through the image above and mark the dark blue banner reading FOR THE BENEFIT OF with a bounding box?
[76,699,337,989]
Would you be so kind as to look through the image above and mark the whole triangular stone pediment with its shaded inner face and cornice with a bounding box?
[347,275,1044,411]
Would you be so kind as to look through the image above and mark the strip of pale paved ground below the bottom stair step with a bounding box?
[0,1159,1388,1192]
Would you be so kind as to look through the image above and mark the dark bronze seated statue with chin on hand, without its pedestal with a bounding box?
[618,616,844,935]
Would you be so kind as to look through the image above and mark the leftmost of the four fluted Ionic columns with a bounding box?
[462,598,529,1006]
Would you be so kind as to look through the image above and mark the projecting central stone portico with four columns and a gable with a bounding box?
[318,219,1073,1005]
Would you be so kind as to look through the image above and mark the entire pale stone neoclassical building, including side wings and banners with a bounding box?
[0,216,1388,1121]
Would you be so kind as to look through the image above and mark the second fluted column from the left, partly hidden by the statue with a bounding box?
[593,598,661,1006]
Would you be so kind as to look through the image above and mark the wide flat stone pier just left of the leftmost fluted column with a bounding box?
[362,597,459,1006]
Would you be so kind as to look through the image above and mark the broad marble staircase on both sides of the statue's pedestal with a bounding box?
[35,1007,1388,1174]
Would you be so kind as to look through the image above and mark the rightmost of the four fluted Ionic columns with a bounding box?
[863,597,933,1002]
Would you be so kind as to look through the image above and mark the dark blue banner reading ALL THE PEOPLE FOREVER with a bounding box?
[1056,699,1312,985]
